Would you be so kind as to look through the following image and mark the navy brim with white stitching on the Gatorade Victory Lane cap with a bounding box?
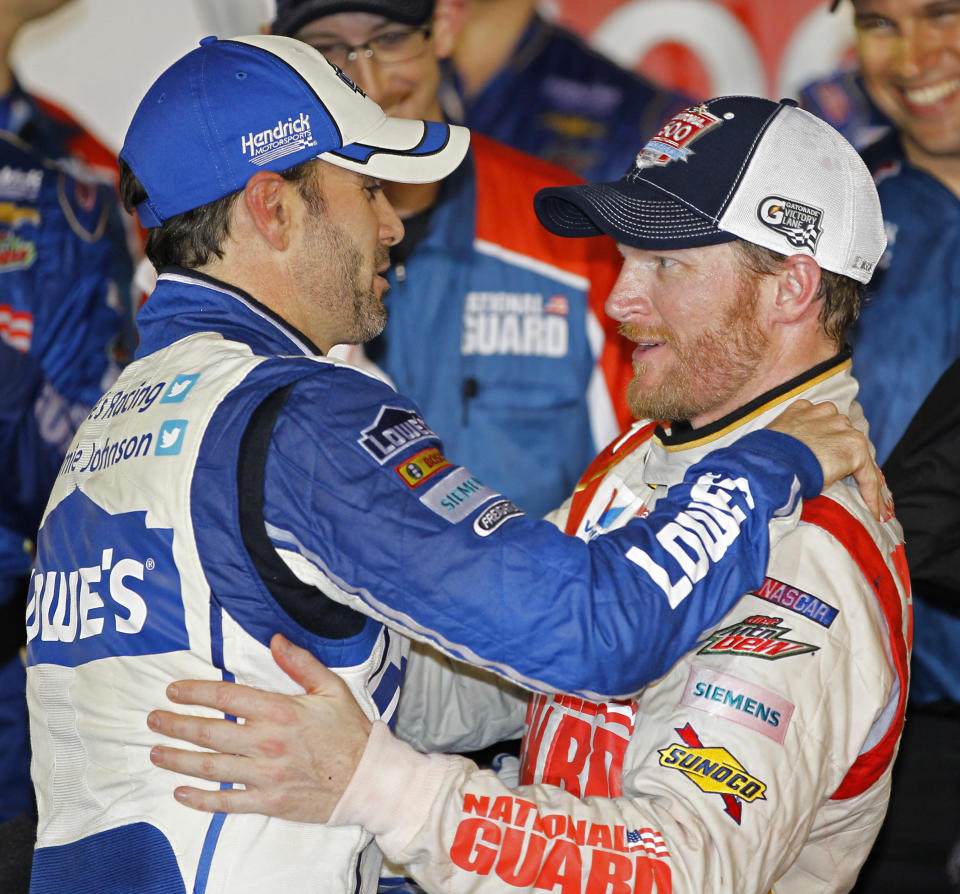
[533,179,737,249]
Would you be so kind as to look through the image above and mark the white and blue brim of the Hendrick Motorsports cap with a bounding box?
[318,118,470,183]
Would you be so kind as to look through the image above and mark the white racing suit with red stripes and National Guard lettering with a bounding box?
[333,355,910,894]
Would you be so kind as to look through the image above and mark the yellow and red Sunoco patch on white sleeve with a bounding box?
[658,723,767,825]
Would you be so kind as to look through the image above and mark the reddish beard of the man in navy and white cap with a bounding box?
[620,284,770,422]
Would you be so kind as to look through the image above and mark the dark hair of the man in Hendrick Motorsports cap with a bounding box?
[120,159,323,269]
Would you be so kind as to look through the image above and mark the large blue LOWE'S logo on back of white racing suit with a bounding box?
[27,490,189,667]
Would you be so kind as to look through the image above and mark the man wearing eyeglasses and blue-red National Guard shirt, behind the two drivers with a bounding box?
[272,0,631,515]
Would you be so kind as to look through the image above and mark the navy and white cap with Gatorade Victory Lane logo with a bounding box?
[534,96,887,283]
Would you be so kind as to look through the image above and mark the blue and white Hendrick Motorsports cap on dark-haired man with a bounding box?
[120,34,470,227]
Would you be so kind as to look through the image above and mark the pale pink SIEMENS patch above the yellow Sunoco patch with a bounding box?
[680,666,794,745]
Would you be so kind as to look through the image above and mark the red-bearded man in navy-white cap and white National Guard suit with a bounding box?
[150,96,910,894]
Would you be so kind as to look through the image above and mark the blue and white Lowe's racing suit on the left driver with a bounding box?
[27,269,822,894]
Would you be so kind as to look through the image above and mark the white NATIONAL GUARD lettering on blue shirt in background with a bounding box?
[460,292,570,357]
